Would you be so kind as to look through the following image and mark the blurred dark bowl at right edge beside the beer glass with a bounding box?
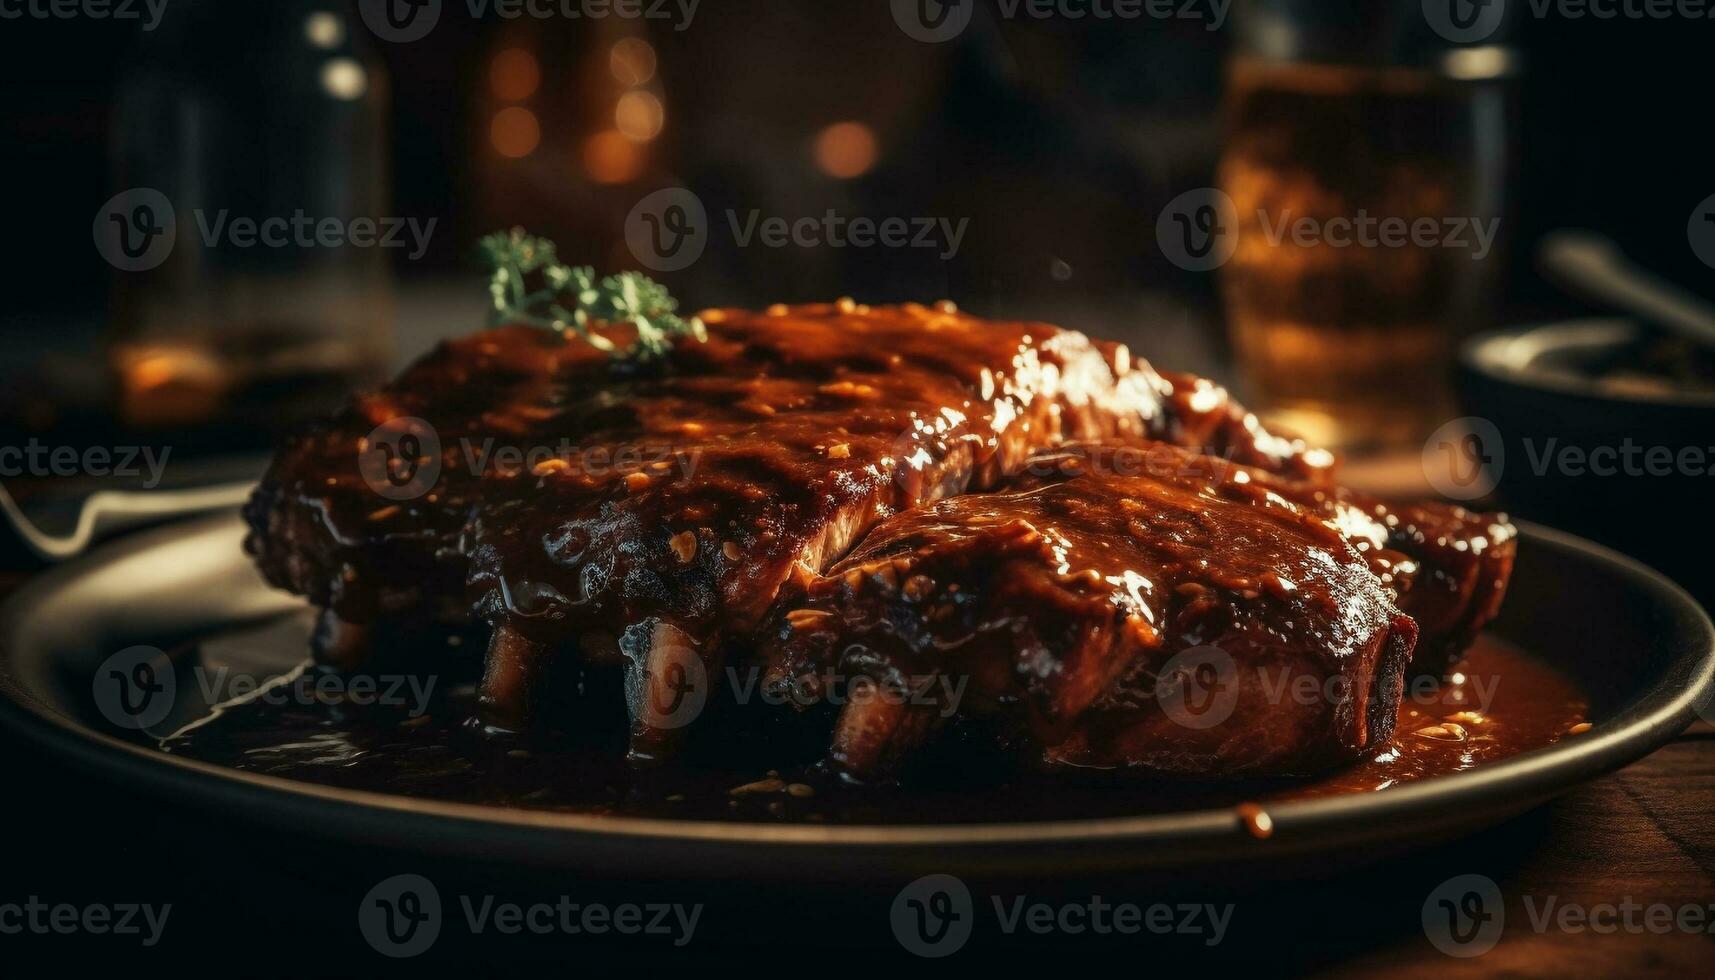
[1459,319,1715,604]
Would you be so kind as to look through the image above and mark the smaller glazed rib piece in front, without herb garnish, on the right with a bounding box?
[763,446,1417,779]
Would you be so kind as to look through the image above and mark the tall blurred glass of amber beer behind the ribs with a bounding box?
[1218,3,1513,451]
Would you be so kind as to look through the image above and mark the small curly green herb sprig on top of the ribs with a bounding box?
[477,228,708,360]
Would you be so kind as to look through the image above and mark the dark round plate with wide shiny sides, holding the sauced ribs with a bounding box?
[0,517,1715,880]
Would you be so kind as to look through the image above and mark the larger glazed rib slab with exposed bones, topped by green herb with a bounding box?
[247,302,1333,755]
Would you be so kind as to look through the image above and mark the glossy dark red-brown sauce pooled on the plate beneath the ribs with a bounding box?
[156,626,1588,824]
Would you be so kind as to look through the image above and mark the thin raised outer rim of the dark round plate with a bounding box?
[0,513,1715,851]
